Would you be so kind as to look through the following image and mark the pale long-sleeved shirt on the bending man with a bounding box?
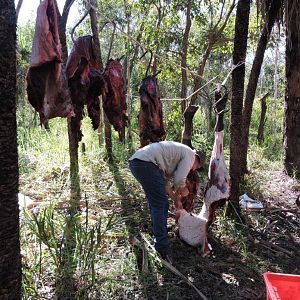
[129,141,195,189]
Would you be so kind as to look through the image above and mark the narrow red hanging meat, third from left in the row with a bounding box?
[103,59,128,141]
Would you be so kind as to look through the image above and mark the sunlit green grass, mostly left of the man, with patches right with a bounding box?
[18,95,290,299]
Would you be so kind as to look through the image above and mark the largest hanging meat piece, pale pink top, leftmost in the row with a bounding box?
[26,0,74,123]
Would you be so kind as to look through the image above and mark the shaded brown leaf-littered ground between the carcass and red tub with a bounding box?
[126,171,300,300]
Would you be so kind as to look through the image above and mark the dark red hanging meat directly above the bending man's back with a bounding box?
[138,75,166,147]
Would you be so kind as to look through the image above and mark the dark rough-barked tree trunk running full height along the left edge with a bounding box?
[0,0,21,300]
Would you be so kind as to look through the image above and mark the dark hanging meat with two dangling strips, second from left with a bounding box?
[67,35,105,141]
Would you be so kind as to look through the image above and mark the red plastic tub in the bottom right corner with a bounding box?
[263,272,300,300]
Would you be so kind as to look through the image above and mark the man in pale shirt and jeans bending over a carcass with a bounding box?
[129,141,204,258]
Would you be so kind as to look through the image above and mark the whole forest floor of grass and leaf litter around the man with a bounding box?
[19,115,300,300]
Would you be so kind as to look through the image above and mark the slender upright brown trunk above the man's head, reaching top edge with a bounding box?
[181,0,192,114]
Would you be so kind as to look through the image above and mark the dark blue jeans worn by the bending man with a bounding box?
[129,159,169,256]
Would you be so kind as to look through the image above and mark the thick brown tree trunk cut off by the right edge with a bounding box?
[284,0,300,178]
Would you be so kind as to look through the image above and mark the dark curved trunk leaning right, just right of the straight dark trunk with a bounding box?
[241,0,281,175]
